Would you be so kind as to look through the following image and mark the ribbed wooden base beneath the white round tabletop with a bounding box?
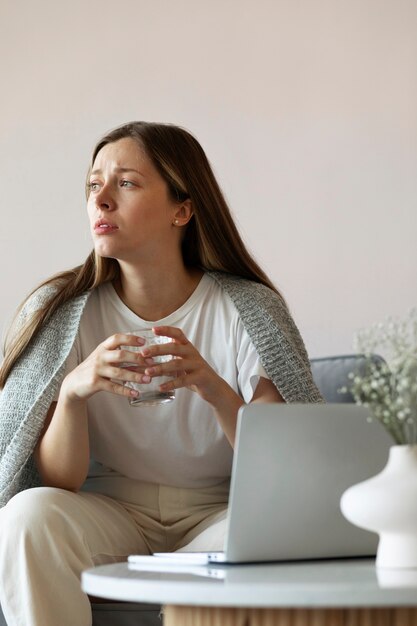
[164,606,417,626]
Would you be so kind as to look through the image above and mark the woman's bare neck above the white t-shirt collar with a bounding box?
[113,266,203,320]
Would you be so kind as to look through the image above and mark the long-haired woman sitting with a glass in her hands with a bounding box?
[0,122,321,626]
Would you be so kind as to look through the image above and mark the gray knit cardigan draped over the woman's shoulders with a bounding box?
[0,272,323,506]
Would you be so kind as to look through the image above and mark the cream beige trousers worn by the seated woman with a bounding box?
[0,478,229,626]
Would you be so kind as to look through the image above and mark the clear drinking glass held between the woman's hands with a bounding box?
[121,330,175,407]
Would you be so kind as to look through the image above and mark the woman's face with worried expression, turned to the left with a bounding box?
[87,138,181,262]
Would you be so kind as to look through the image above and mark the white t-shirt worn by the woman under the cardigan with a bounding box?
[61,274,267,487]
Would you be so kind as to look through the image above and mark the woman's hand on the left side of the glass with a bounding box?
[60,333,152,402]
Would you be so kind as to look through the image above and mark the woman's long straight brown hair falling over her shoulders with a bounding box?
[0,122,277,389]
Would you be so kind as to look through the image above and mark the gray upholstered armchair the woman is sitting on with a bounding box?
[0,355,376,626]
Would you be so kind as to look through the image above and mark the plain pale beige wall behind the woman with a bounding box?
[0,0,417,356]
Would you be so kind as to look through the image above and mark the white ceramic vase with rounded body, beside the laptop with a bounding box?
[340,445,417,568]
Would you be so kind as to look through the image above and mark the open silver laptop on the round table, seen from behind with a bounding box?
[129,404,393,566]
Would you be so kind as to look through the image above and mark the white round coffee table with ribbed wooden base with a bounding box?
[82,559,417,626]
